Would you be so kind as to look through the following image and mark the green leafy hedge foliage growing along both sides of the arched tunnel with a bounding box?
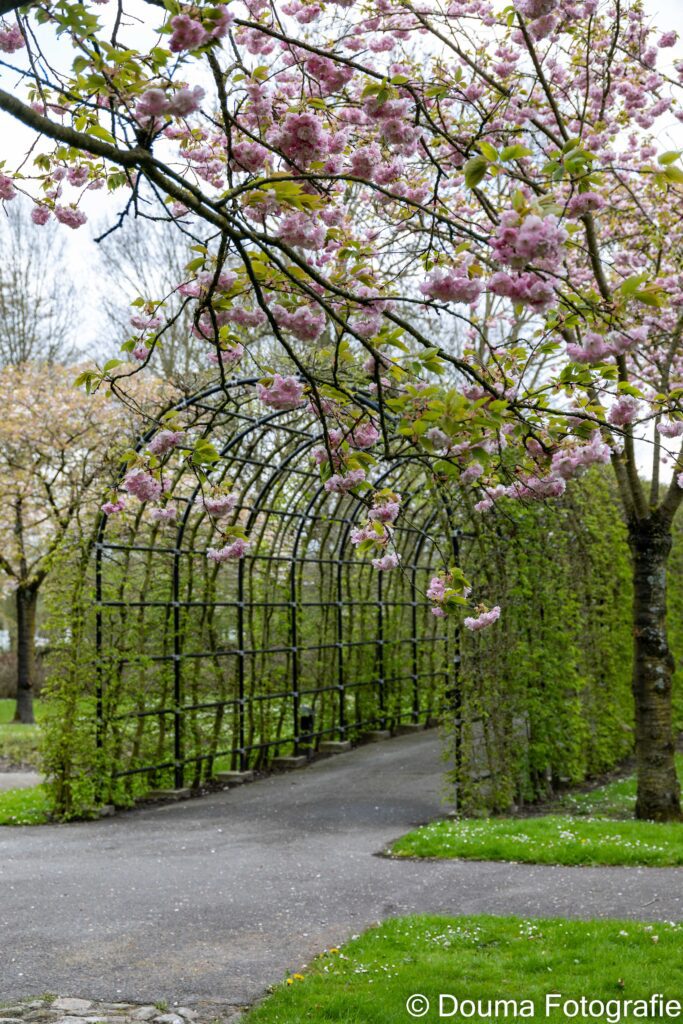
[38,471,683,817]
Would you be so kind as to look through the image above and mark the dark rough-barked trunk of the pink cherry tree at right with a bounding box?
[629,516,681,821]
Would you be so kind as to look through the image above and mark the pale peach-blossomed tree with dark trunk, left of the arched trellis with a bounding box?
[0,364,160,723]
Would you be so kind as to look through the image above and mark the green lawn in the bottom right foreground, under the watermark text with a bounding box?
[244,916,683,1024]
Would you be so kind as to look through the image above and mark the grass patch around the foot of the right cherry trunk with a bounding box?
[390,756,683,867]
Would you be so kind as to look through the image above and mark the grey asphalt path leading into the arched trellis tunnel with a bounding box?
[0,732,683,1005]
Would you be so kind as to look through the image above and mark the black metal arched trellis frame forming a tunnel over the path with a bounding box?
[94,379,458,802]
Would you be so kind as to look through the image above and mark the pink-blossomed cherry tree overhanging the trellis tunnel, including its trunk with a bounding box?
[0,0,683,819]
